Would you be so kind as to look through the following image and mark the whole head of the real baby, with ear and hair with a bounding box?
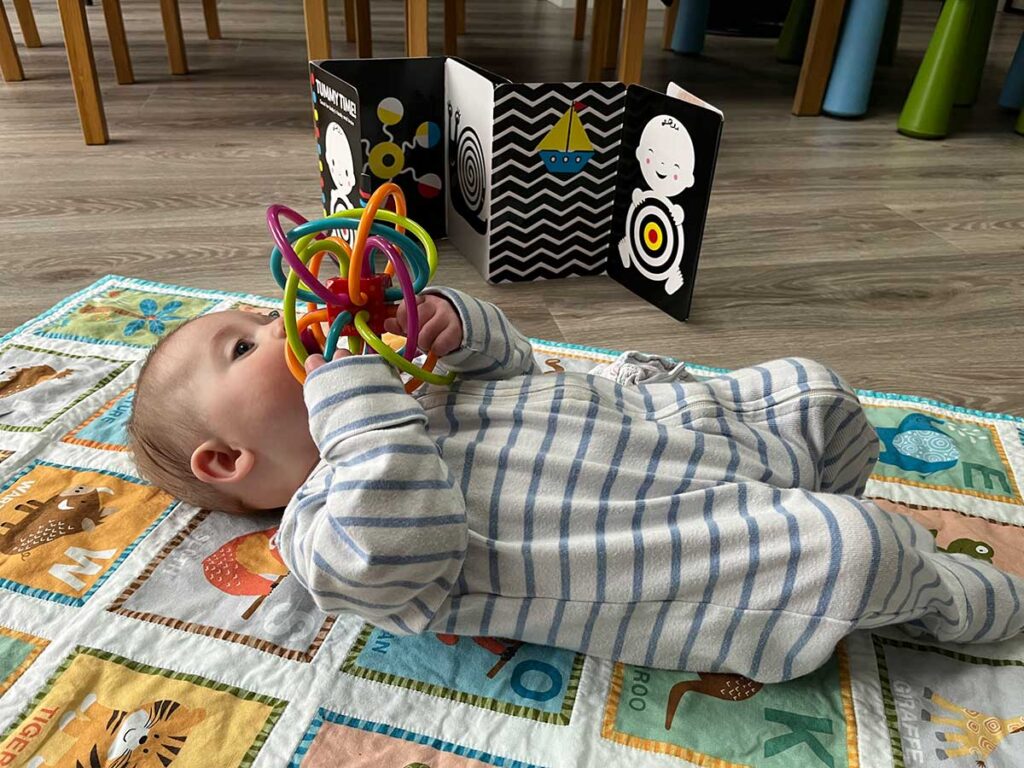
[128,311,319,513]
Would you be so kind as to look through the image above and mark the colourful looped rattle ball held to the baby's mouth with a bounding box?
[266,182,455,392]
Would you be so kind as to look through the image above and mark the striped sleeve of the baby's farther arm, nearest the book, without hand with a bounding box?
[423,288,535,380]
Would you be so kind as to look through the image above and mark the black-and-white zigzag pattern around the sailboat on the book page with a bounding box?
[487,83,626,283]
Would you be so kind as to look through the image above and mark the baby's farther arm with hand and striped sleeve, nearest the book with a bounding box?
[386,288,534,380]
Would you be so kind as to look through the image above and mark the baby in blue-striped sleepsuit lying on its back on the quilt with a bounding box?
[129,288,1024,682]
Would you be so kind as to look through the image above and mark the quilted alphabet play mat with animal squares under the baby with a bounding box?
[0,276,1024,768]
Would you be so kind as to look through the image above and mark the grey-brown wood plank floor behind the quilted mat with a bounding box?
[0,0,1024,415]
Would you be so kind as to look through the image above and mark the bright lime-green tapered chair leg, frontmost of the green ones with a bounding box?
[897,0,975,138]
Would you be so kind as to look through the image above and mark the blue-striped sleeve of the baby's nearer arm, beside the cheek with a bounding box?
[278,355,467,635]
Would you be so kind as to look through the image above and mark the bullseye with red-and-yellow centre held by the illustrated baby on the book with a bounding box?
[624,197,684,294]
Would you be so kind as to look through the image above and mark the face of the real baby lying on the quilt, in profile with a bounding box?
[164,311,319,507]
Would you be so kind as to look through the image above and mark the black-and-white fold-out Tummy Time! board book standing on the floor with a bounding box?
[309,56,723,321]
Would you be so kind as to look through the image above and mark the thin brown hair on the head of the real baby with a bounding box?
[128,317,252,514]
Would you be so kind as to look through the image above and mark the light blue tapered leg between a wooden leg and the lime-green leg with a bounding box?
[821,0,889,118]
